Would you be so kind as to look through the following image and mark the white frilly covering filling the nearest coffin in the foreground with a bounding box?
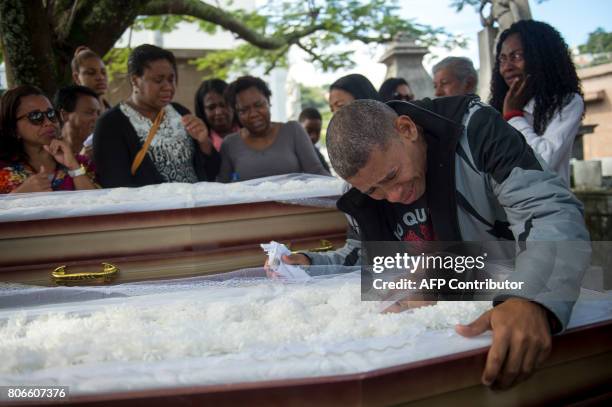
[0,269,612,394]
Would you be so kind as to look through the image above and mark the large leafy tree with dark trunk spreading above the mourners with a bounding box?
[0,0,465,93]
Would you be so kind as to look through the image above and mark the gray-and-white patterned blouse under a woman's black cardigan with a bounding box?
[119,102,198,183]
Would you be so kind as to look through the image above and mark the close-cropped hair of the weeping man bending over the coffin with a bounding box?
[326,99,399,179]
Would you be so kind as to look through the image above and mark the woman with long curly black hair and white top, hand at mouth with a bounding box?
[490,20,584,185]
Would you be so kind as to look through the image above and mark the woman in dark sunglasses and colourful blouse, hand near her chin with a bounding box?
[0,85,96,193]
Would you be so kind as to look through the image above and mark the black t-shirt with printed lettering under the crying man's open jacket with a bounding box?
[393,194,436,242]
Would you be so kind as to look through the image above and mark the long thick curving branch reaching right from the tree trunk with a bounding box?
[140,0,324,50]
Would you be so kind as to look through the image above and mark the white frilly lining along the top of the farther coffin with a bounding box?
[0,174,345,222]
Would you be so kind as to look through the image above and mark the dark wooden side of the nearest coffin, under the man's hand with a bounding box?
[8,320,612,406]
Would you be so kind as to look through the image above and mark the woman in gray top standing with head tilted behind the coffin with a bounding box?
[218,76,329,182]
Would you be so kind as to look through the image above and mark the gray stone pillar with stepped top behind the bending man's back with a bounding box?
[379,33,434,99]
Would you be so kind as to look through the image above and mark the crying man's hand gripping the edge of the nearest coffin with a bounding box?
[456,298,551,389]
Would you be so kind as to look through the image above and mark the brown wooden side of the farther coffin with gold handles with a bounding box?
[0,202,347,285]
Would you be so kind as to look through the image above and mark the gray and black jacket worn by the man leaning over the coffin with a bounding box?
[307,96,590,331]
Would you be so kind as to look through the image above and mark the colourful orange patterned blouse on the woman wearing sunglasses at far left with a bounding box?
[0,155,95,194]
